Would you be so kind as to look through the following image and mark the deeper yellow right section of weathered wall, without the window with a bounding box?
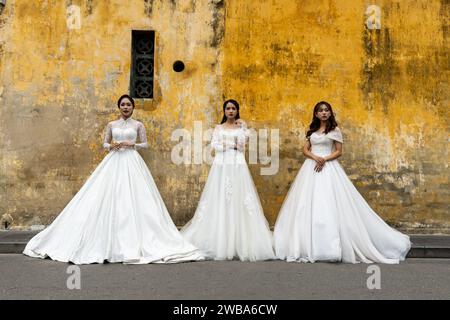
[222,0,450,232]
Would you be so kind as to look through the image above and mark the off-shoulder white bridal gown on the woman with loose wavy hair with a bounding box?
[274,128,411,264]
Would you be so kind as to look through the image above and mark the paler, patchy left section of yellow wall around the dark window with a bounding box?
[0,0,223,225]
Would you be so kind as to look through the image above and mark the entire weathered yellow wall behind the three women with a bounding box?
[0,0,450,232]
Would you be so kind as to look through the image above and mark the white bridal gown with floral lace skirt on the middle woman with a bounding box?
[181,125,275,261]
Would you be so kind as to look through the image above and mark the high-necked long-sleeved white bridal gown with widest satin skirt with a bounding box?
[23,118,204,264]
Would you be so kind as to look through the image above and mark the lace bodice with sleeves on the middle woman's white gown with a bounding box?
[211,123,248,152]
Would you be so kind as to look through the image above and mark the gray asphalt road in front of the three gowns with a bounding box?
[0,254,450,299]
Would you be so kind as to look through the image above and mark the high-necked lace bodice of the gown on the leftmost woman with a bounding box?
[103,117,148,150]
